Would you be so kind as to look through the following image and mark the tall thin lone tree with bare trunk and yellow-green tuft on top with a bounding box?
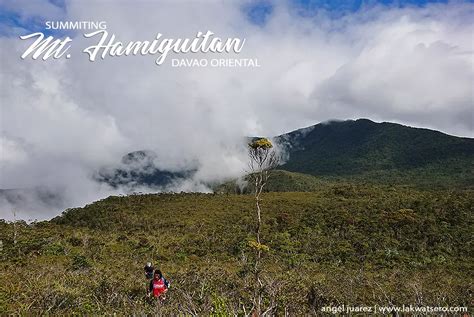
[248,138,279,315]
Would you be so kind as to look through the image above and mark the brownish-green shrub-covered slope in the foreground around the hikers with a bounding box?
[0,184,474,315]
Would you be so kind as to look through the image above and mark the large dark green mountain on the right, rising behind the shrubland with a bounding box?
[276,119,474,186]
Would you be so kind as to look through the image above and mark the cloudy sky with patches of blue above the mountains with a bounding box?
[0,0,474,219]
